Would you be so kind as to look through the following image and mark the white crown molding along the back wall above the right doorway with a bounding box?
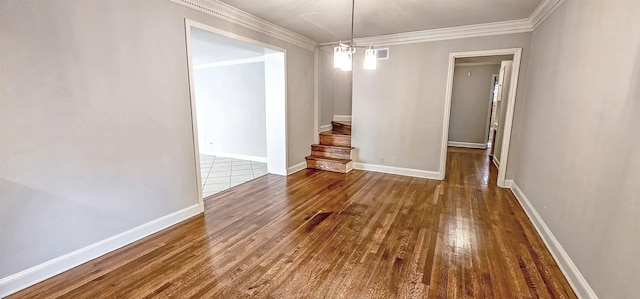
[320,0,565,46]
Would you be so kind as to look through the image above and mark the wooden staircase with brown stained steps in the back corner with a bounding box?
[306,121,353,173]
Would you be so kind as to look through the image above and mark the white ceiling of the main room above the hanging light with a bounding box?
[220,0,542,43]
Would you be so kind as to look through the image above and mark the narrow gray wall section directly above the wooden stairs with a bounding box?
[318,46,352,126]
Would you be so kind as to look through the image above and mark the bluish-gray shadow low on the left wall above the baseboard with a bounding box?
[0,179,132,279]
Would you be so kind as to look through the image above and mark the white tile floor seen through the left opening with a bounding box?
[200,155,267,198]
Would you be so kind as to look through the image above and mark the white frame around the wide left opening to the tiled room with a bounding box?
[184,19,288,204]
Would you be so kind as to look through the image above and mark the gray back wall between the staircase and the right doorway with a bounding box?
[352,33,531,174]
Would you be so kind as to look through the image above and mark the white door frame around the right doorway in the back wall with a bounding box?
[440,48,522,188]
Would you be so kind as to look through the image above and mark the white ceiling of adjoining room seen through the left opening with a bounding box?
[191,27,270,65]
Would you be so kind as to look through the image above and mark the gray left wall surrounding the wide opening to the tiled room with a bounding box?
[0,0,314,277]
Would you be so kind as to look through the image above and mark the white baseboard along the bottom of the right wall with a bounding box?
[508,181,598,298]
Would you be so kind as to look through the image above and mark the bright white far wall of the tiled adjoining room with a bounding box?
[194,62,267,158]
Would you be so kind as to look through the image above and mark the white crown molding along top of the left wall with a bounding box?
[169,0,318,51]
